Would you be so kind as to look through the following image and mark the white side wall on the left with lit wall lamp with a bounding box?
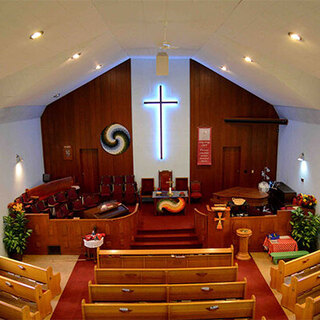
[0,119,44,255]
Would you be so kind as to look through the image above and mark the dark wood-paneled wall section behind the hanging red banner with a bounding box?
[190,60,278,198]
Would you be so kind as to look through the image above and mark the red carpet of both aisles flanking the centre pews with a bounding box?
[51,254,287,320]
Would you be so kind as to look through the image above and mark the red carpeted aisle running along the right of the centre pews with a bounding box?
[235,259,288,320]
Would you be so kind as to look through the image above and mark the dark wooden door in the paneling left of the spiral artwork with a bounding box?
[80,149,99,193]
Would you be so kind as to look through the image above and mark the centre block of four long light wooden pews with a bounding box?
[82,246,256,320]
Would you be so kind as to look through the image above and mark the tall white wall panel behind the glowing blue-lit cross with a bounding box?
[131,59,190,186]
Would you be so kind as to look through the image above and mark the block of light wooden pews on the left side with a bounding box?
[0,256,61,320]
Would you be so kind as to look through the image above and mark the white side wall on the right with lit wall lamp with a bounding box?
[277,120,320,205]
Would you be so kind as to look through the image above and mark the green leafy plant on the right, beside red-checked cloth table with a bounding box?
[290,207,320,251]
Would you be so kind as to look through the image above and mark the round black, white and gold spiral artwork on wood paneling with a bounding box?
[100,123,130,155]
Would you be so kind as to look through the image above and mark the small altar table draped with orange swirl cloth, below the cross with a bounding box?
[152,191,188,215]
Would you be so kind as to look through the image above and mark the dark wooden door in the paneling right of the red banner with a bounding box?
[222,147,241,189]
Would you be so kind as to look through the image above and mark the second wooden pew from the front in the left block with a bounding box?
[0,276,52,319]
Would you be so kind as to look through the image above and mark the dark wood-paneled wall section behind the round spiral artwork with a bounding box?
[41,60,133,191]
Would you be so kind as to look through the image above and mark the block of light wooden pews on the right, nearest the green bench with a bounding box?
[270,250,320,320]
